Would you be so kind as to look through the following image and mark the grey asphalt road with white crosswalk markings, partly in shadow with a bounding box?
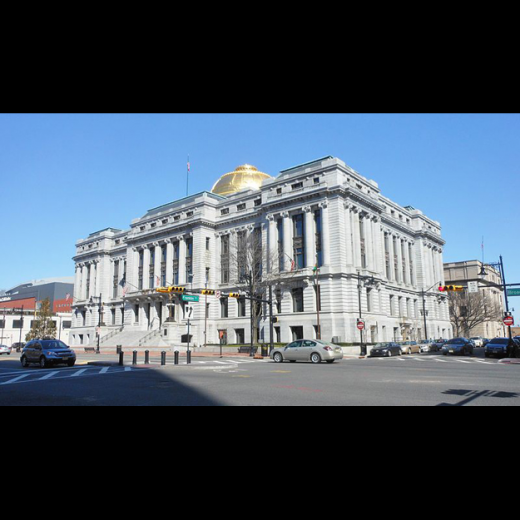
[0,349,520,406]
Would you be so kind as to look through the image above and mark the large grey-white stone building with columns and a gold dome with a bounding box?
[71,157,452,346]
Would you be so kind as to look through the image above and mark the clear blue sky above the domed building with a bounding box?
[0,114,520,314]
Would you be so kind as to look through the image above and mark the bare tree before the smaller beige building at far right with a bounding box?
[449,291,501,337]
